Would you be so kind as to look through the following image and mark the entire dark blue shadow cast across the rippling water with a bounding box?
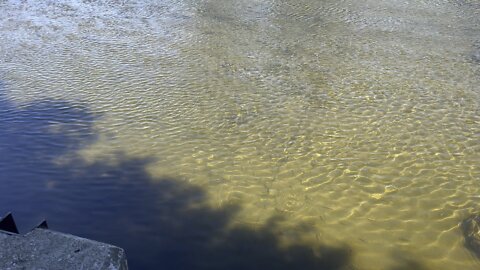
[0,83,353,269]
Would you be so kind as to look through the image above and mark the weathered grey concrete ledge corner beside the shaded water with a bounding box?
[0,229,128,270]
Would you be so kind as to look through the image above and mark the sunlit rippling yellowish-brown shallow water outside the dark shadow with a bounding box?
[0,0,480,269]
